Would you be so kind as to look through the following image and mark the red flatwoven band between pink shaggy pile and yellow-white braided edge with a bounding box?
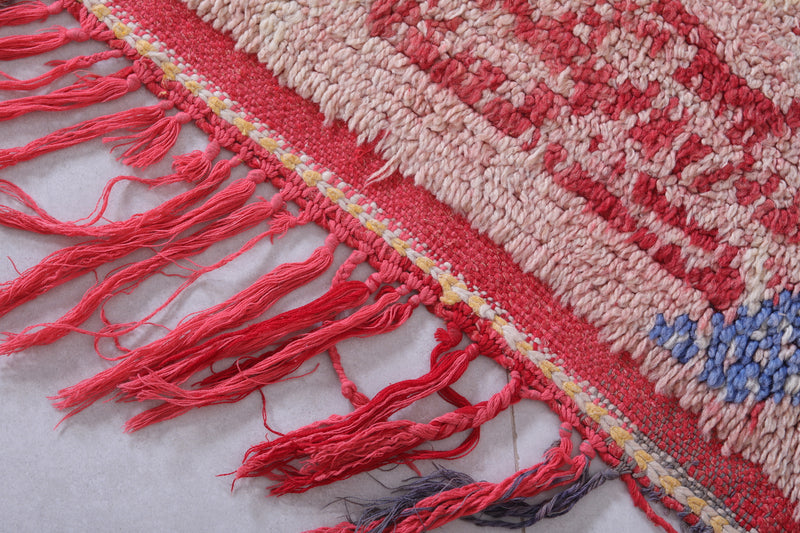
[72,0,795,531]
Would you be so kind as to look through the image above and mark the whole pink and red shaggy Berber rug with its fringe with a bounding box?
[0,0,800,533]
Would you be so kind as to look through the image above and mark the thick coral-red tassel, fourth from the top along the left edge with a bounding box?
[0,67,142,121]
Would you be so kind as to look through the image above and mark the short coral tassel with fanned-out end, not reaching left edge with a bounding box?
[103,108,192,168]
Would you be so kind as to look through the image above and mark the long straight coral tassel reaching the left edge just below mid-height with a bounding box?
[0,165,248,324]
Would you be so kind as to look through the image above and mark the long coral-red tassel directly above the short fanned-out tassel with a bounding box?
[0,100,173,168]
